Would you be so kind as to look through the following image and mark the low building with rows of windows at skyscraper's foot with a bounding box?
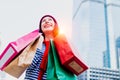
[78,67,120,80]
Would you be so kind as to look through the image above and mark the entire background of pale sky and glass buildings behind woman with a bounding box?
[0,0,120,80]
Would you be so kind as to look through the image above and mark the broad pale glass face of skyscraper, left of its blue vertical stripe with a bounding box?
[72,0,107,67]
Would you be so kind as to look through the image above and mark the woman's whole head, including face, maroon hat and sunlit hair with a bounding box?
[39,15,59,38]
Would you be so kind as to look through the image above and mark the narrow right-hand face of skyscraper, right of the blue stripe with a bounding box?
[104,0,120,69]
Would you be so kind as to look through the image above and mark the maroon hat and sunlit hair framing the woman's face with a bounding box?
[39,15,59,37]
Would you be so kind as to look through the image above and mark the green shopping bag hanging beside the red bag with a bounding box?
[47,40,76,80]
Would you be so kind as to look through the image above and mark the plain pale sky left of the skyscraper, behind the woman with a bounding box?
[0,0,72,80]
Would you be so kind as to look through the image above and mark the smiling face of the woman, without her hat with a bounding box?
[41,17,55,34]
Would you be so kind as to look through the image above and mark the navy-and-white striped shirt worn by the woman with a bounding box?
[24,44,47,80]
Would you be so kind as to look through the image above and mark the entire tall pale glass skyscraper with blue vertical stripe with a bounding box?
[72,0,120,69]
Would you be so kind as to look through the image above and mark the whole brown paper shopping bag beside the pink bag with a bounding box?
[3,37,43,78]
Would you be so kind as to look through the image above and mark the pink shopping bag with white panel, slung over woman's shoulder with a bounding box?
[0,29,40,70]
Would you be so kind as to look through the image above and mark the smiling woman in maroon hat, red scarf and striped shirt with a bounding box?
[25,15,76,80]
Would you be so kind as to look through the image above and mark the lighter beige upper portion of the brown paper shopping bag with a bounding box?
[18,35,44,66]
